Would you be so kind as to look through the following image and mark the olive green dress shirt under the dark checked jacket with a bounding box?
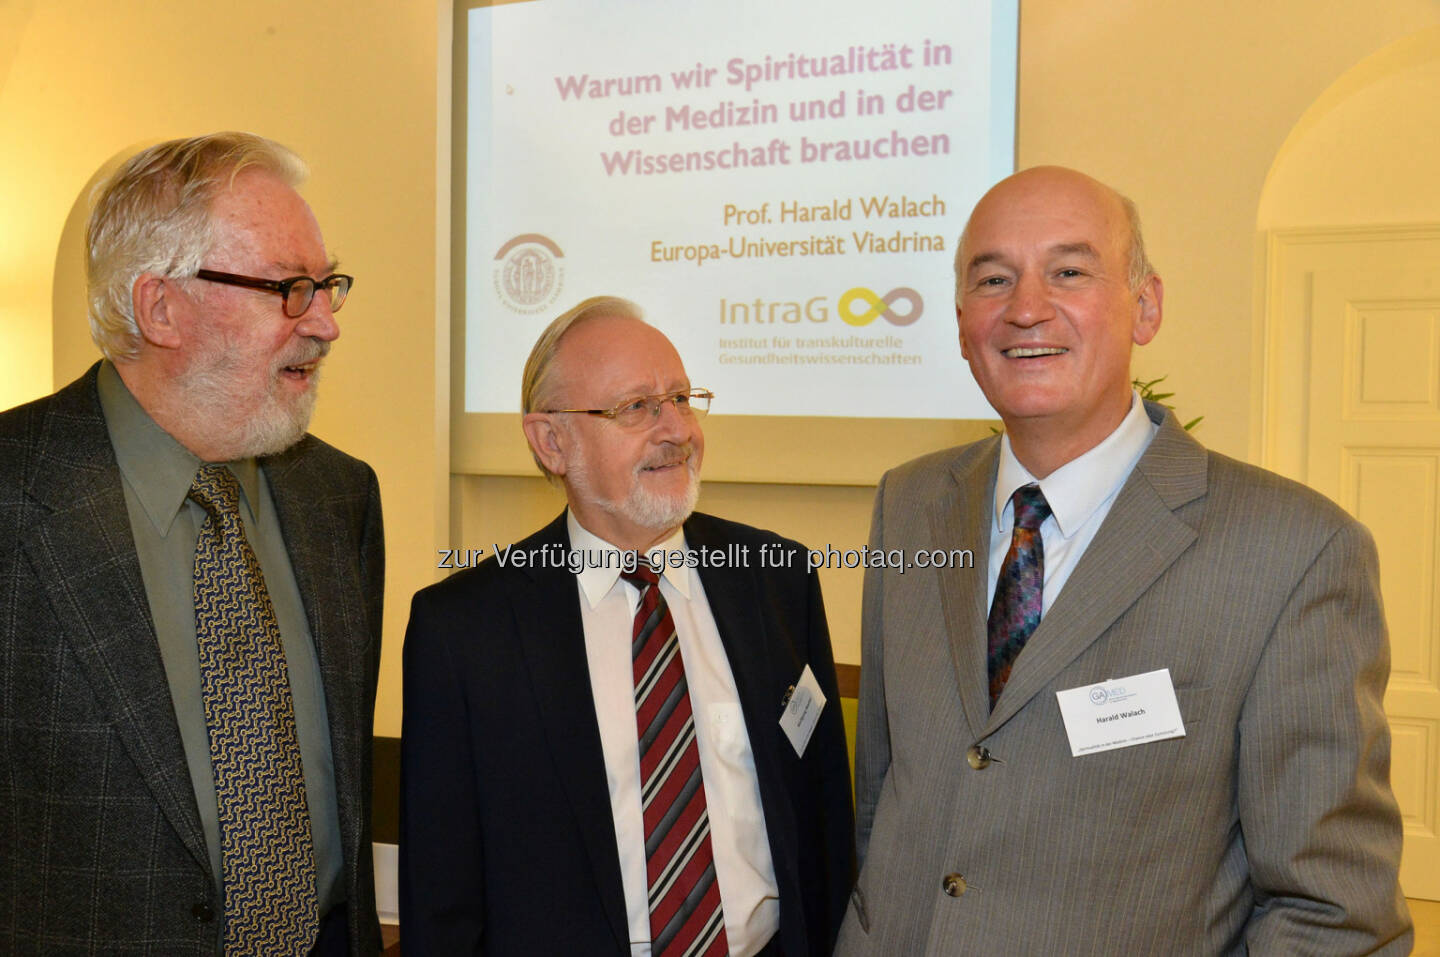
[96,361,344,914]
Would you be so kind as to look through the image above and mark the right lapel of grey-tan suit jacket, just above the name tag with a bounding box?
[981,406,1207,734]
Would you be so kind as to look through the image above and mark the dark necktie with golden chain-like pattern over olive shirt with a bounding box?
[190,465,320,954]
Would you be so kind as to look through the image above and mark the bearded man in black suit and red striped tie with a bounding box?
[400,298,854,957]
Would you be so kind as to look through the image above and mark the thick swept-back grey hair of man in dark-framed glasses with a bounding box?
[85,132,308,361]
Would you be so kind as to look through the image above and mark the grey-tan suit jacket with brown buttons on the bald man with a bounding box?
[837,406,1411,957]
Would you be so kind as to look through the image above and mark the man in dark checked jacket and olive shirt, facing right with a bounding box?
[0,132,384,954]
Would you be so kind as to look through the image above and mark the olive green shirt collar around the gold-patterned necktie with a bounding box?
[95,360,261,537]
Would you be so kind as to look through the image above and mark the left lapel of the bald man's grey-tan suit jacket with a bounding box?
[929,440,999,734]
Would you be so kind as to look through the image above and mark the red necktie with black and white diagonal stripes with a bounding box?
[621,566,729,957]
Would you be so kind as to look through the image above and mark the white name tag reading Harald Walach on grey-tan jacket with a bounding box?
[1056,668,1185,757]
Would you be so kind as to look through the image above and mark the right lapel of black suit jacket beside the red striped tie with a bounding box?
[685,515,806,899]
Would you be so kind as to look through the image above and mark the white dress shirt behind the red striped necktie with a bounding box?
[566,512,780,957]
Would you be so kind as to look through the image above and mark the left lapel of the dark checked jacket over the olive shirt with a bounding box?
[22,366,210,874]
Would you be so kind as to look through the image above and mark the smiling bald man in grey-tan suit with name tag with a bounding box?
[837,167,1411,957]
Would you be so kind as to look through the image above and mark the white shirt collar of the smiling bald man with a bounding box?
[995,391,1159,538]
